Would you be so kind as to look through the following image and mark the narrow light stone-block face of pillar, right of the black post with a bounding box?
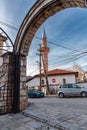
[20,55,27,111]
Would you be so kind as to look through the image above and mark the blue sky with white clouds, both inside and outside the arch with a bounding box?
[0,0,87,75]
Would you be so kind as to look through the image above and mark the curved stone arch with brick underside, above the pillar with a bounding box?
[15,0,85,56]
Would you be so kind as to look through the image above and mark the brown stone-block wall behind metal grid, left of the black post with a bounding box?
[0,52,14,114]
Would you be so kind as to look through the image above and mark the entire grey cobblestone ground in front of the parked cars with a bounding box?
[0,97,87,130]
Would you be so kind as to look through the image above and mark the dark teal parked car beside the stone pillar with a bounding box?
[28,90,44,98]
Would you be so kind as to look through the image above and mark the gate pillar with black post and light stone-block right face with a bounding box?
[13,54,27,113]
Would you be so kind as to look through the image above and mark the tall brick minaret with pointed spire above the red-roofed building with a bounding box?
[40,29,49,73]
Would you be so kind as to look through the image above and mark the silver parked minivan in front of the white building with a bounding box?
[58,84,87,98]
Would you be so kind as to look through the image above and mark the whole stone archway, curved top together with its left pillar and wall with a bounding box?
[0,0,85,114]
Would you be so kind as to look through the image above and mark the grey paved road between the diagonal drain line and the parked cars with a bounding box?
[26,96,87,130]
